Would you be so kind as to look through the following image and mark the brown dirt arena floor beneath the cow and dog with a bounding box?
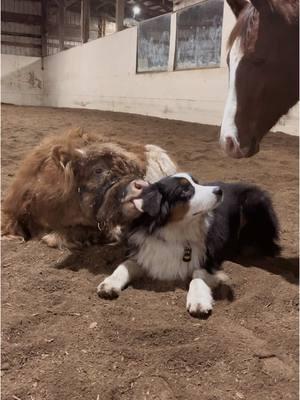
[2,105,298,400]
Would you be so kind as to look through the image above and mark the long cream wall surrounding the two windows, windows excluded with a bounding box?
[3,2,298,134]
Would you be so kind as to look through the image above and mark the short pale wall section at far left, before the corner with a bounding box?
[1,54,43,106]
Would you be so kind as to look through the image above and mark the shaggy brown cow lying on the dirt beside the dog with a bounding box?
[2,129,176,248]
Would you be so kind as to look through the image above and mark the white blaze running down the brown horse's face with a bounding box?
[220,39,243,144]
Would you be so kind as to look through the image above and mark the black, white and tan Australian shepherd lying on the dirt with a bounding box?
[97,173,280,317]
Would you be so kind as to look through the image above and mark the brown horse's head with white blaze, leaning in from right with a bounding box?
[220,0,299,158]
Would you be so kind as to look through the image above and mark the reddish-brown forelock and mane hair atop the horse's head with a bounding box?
[228,0,299,52]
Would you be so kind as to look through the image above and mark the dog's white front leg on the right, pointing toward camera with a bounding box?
[186,270,214,317]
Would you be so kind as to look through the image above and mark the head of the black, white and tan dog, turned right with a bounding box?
[132,173,222,232]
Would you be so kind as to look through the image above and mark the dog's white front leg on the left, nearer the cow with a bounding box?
[97,260,142,299]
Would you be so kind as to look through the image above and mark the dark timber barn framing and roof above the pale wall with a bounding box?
[1,0,173,56]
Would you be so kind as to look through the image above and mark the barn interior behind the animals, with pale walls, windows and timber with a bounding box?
[1,0,299,134]
